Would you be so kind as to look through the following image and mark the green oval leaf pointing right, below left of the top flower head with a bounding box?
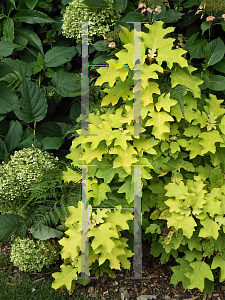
[44,46,77,68]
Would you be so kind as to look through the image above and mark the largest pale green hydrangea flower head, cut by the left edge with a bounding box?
[0,147,58,214]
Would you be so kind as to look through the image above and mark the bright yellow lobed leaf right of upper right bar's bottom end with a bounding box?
[145,111,174,140]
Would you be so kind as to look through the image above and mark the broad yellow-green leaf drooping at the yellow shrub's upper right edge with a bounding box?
[170,66,203,98]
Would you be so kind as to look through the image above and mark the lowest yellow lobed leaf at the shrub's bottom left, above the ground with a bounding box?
[52,265,78,292]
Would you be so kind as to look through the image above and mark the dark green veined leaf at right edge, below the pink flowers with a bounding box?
[205,38,225,66]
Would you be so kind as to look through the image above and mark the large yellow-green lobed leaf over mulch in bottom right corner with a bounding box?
[184,261,214,292]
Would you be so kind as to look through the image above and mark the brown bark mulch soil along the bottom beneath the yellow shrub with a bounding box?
[0,241,225,300]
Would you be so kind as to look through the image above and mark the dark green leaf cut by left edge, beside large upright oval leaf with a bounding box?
[0,82,17,115]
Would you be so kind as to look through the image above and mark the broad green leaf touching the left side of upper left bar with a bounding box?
[52,71,81,97]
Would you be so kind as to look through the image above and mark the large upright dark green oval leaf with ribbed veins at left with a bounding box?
[14,79,48,123]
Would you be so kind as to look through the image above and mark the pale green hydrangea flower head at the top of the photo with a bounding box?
[62,0,120,44]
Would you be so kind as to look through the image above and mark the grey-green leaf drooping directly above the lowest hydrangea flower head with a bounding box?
[29,225,63,241]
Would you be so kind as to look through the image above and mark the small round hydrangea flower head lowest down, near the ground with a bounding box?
[10,237,60,272]
